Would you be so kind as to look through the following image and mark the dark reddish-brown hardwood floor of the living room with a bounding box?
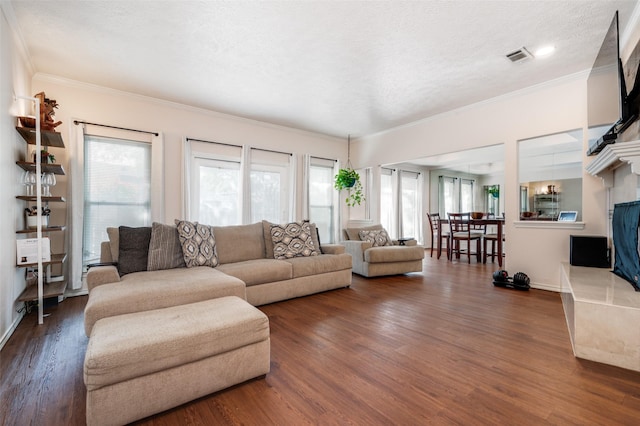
[0,257,640,425]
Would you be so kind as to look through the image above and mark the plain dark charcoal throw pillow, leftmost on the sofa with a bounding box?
[118,226,151,276]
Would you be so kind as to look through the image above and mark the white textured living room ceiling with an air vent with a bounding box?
[10,0,637,137]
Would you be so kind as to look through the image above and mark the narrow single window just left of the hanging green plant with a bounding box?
[309,157,337,243]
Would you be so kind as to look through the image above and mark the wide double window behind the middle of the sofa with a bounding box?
[185,139,294,226]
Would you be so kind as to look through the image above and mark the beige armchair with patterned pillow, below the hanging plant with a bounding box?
[340,225,424,277]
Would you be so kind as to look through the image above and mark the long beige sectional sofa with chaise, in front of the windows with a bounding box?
[85,221,352,336]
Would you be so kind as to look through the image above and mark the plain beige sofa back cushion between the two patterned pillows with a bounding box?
[213,222,265,264]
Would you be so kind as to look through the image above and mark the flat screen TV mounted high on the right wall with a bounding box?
[587,11,637,155]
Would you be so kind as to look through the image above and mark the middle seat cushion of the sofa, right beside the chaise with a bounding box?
[218,259,293,286]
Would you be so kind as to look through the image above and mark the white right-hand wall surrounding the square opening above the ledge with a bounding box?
[352,72,607,290]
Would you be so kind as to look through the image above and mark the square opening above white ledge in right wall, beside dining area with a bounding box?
[518,129,582,221]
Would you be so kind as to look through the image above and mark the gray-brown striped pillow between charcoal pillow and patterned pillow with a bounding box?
[147,222,186,271]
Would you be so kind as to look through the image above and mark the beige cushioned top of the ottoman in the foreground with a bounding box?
[84,296,269,390]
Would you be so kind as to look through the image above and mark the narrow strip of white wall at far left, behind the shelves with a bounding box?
[0,3,32,348]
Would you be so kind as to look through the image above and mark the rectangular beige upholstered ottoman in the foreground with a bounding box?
[84,296,270,425]
